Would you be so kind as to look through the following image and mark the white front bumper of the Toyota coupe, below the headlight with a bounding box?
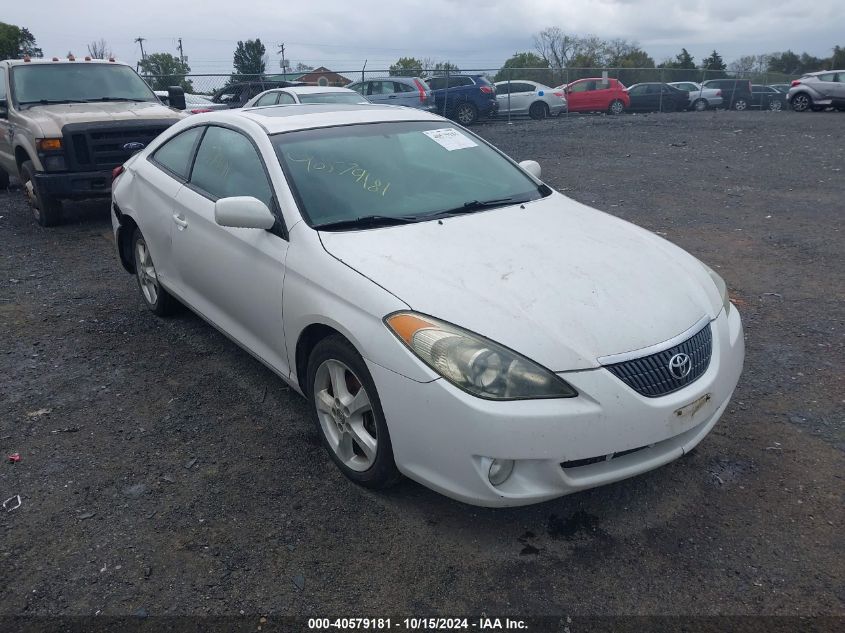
[368,308,745,507]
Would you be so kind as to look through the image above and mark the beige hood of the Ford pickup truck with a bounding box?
[25,101,187,137]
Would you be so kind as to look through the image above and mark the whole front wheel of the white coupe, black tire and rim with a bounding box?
[306,334,402,490]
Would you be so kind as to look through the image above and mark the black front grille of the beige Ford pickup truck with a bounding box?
[62,120,176,171]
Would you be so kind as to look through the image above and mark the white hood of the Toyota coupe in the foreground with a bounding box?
[320,193,722,371]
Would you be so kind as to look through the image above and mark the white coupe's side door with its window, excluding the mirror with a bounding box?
[171,125,288,374]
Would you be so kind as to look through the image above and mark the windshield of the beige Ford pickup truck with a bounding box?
[12,62,156,105]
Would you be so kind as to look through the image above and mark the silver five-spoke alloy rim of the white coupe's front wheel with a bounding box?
[314,359,378,472]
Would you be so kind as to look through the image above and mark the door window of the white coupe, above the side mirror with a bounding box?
[191,126,273,208]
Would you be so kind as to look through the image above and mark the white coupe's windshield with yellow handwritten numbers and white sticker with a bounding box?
[271,121,551,228]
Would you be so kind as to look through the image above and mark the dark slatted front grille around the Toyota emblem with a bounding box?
[605,323,713,398]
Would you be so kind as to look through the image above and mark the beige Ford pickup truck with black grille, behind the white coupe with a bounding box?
[0,56,187,226]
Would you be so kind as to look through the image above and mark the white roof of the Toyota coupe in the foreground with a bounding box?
[227,103,442,134]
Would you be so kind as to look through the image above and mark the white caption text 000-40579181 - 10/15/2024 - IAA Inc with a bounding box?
[308,617,528,631]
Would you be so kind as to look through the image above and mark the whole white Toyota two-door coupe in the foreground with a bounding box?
[113,104,745,506]
